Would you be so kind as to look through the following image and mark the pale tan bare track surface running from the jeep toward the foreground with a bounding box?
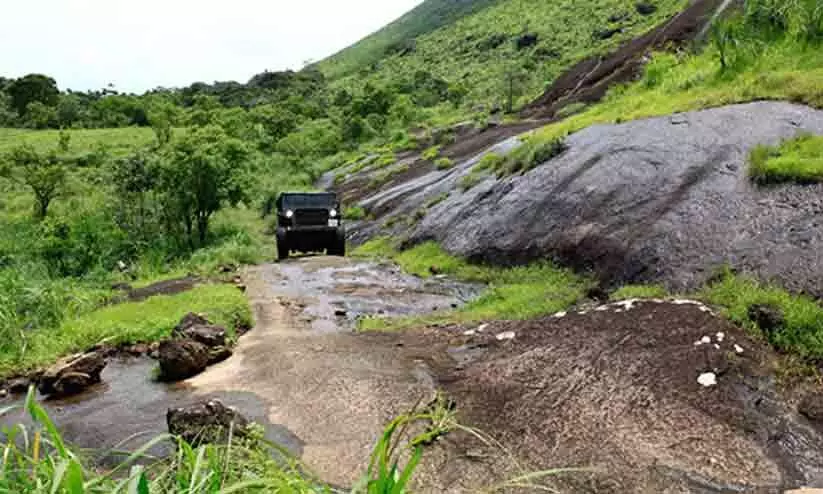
[189,257,480,485]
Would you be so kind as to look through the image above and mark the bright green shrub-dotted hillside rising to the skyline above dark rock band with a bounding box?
[318,0,687,113]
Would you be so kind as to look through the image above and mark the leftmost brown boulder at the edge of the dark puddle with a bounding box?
[37,352,106,395]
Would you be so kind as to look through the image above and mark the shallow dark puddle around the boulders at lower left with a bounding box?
[0,358,303,466]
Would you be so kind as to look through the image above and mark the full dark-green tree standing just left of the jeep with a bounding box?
[157,126,250,247]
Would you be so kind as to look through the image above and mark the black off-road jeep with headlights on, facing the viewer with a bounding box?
[277,192,346,260]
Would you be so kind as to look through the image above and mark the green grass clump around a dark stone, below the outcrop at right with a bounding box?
[699,274,823,359]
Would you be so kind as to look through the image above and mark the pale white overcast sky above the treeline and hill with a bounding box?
[0,0,421,92]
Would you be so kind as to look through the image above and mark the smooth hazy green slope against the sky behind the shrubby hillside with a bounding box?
[319,0,499,78]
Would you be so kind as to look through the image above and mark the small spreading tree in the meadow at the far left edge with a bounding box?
[0,145,67,219]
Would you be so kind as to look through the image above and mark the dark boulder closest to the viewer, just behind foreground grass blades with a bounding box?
[166,400,249,445]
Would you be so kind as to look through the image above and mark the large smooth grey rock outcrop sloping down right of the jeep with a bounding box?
[354,102,823,296]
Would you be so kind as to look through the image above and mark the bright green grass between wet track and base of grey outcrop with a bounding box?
[355,238,591,330]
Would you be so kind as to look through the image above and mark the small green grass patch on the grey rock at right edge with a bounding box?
[749,134,823,185]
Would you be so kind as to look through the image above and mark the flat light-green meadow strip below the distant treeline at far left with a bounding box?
[0,127,155,157]
